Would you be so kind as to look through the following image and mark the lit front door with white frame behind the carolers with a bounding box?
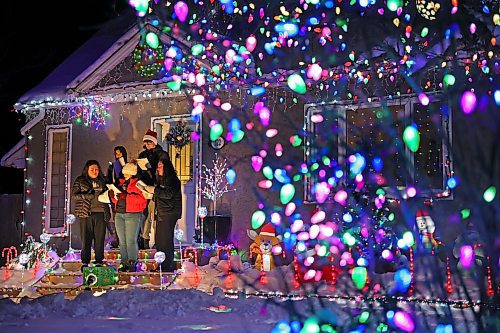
[151,115,197,244]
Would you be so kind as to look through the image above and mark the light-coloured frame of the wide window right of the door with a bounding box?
[303,93,454,204]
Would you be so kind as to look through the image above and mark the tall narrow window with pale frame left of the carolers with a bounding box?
[45,125,71,234]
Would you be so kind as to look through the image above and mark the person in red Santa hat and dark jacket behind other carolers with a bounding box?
[138,130,169,248]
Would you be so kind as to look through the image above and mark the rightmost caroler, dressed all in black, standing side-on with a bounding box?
[154,158,182,272]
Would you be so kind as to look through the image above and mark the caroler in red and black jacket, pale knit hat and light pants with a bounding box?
[110,163,147,272]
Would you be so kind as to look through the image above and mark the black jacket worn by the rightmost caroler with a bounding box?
[154,175,182,219]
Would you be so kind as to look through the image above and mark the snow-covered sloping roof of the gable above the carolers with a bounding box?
[17,12,137,104]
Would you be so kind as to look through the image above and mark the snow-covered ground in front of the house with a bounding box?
[0,256,492,333]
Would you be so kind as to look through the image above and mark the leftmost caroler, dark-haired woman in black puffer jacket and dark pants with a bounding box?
[71,160,110,268]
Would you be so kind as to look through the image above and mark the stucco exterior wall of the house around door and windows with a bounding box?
[26,90,500,255]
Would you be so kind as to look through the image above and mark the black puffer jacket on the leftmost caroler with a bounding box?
[71,176,111,222]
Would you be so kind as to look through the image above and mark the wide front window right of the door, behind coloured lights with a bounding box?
[304,97,452,202]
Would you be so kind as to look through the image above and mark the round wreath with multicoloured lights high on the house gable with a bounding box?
[132,44,166,78]
